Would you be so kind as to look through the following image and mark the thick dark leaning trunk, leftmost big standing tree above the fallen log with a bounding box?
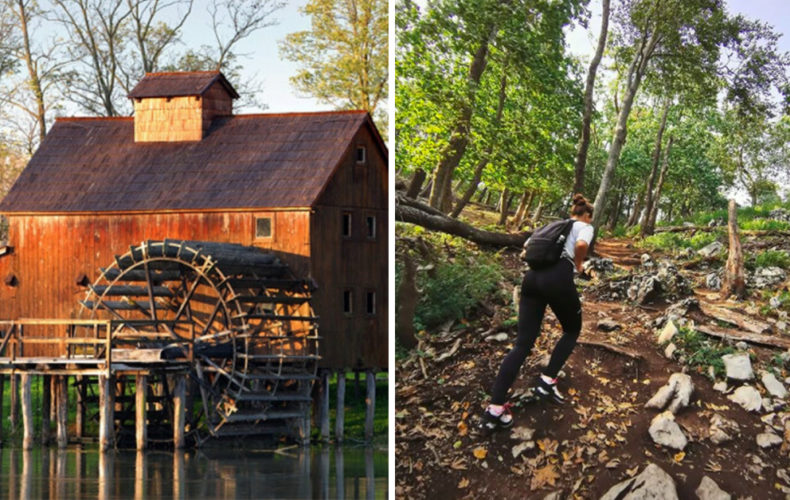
[429,27,496,209]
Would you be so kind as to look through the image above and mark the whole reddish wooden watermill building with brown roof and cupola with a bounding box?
[0,72,389,450]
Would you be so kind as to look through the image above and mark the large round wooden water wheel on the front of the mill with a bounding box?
[76,240,319,444]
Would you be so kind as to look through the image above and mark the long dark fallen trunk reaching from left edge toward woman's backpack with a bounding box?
[395,196,532,248]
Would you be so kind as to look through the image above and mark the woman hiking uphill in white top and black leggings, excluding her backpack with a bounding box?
[483,194,593,430]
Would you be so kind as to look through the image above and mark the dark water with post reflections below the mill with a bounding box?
[0,443,387,500]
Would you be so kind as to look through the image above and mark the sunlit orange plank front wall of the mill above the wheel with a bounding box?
[0,209,310,355]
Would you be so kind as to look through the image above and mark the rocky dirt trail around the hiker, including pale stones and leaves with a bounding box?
[395,235,790,499]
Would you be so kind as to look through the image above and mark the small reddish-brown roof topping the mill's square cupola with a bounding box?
[129,71,239,99]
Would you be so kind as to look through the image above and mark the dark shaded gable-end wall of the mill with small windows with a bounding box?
[311,127,389,369]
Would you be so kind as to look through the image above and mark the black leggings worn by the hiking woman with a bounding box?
[491,258,582,405]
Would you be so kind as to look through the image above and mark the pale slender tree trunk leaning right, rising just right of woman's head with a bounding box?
[592,30,659,228]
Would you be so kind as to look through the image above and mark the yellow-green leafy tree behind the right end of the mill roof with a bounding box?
[280,0,389,128]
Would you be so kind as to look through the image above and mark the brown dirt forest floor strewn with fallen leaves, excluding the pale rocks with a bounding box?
[395,220,790,499]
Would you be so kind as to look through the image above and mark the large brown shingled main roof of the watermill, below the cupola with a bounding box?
[0,111,387,213]
